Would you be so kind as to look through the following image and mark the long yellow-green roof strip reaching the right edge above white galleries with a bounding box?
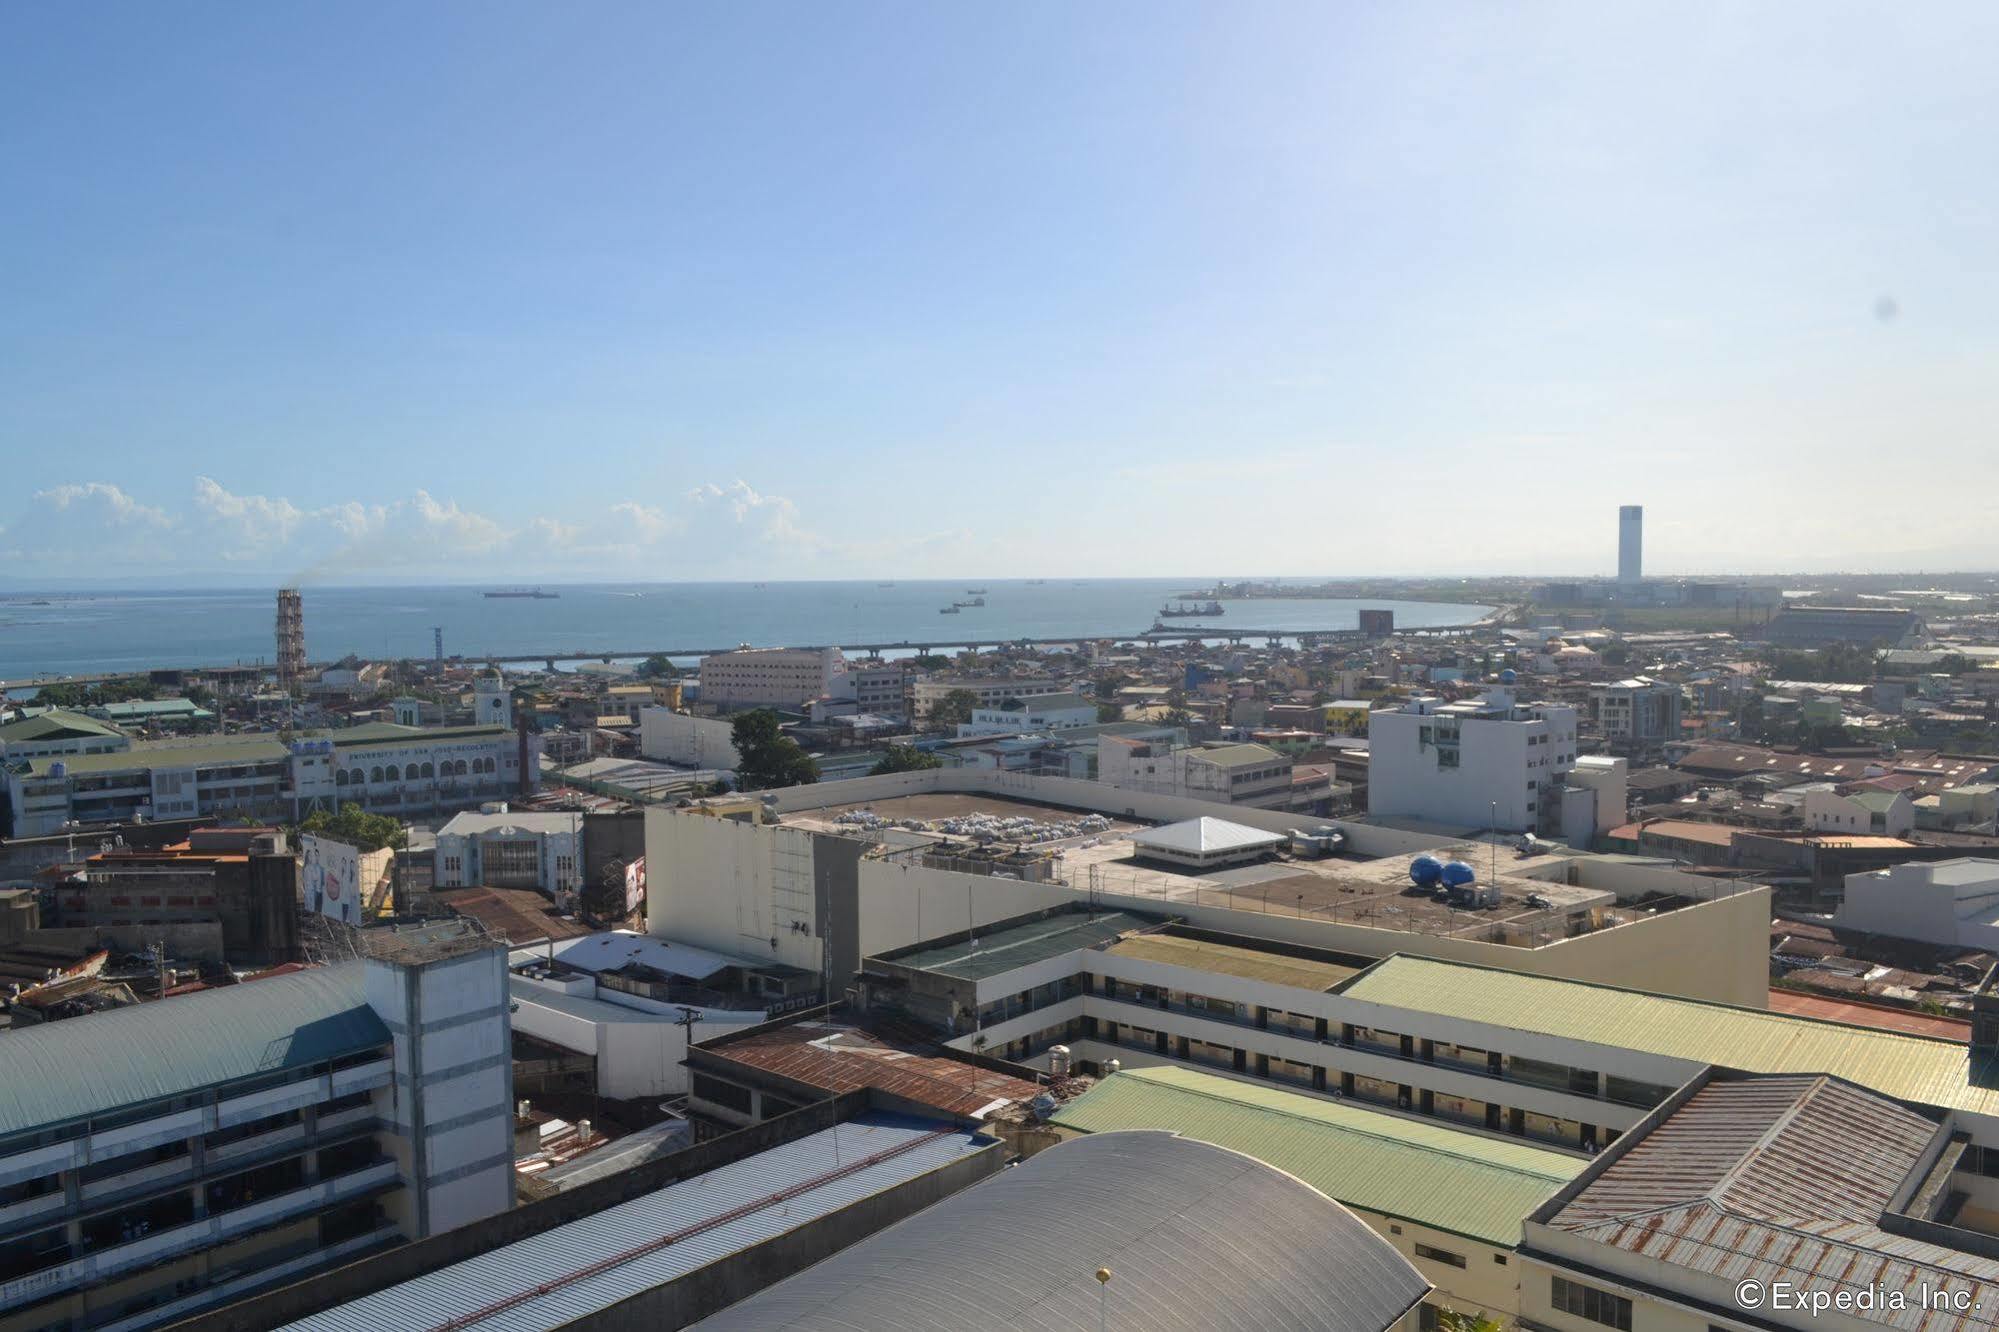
[1339,954,1999,1114]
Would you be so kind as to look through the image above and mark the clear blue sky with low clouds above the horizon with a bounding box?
[0,0,1999,586]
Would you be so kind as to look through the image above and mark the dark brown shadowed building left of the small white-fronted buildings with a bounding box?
[67,828,298,962]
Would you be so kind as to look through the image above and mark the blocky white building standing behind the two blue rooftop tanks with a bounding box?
[1367,690,1575,834]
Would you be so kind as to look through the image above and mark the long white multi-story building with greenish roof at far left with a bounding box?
[4,722,540,836]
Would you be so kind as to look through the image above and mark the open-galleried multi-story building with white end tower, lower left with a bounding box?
[0,924,514,1332]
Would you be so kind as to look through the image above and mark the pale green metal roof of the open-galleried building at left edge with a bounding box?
[0,962,390,1138]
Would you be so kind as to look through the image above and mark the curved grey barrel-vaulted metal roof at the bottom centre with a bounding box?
[698,1132,1429,1332]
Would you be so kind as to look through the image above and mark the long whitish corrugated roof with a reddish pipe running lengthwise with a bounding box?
[286,1114,998,1332]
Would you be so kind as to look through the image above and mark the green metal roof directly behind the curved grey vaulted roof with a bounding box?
[1053,1068,1589,1248]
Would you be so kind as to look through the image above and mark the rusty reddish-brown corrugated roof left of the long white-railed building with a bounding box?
[694,1018,1041,1116]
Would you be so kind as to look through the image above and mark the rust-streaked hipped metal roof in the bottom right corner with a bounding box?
[1529,1076,1999,1332]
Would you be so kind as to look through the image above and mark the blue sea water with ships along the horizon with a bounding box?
[0,578,1487,680]
